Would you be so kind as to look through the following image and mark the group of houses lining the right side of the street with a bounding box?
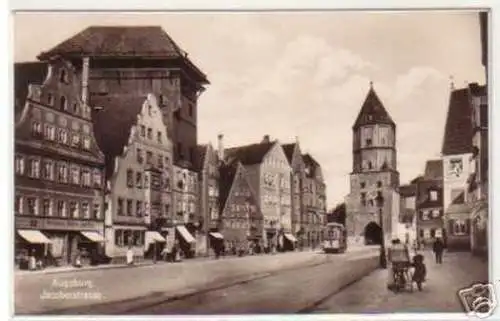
[394,13,489,255]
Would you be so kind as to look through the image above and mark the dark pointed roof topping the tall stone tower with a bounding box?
[353,87,396,129]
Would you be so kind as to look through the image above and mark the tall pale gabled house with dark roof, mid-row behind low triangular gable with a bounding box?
[224,135,292,248]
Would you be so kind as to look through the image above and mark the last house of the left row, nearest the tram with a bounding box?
[302,154,326,247]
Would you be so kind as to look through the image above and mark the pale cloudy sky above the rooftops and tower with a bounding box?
[13,11,484,206]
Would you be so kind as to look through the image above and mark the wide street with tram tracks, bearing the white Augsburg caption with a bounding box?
[15,247,378,314]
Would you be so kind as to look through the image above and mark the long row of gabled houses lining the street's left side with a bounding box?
[14,27,326,264]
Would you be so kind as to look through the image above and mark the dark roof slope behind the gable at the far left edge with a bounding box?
[14,62,48,114]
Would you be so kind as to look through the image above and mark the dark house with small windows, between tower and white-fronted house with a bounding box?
[416,159,447,246]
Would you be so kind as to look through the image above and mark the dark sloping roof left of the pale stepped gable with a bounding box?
[90,96,146,177]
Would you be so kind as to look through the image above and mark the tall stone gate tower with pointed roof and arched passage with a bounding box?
[346,83,399,243]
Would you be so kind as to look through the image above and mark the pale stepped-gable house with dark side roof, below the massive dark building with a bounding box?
[91,94,173,263]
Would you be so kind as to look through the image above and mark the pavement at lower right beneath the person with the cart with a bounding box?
[313,252,488,313]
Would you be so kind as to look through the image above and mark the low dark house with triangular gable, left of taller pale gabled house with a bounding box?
[220,160,263,254]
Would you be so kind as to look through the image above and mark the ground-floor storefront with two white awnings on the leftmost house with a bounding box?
[15,217,104,266]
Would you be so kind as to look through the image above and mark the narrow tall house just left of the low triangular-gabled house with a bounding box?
[196,142,222,255]
